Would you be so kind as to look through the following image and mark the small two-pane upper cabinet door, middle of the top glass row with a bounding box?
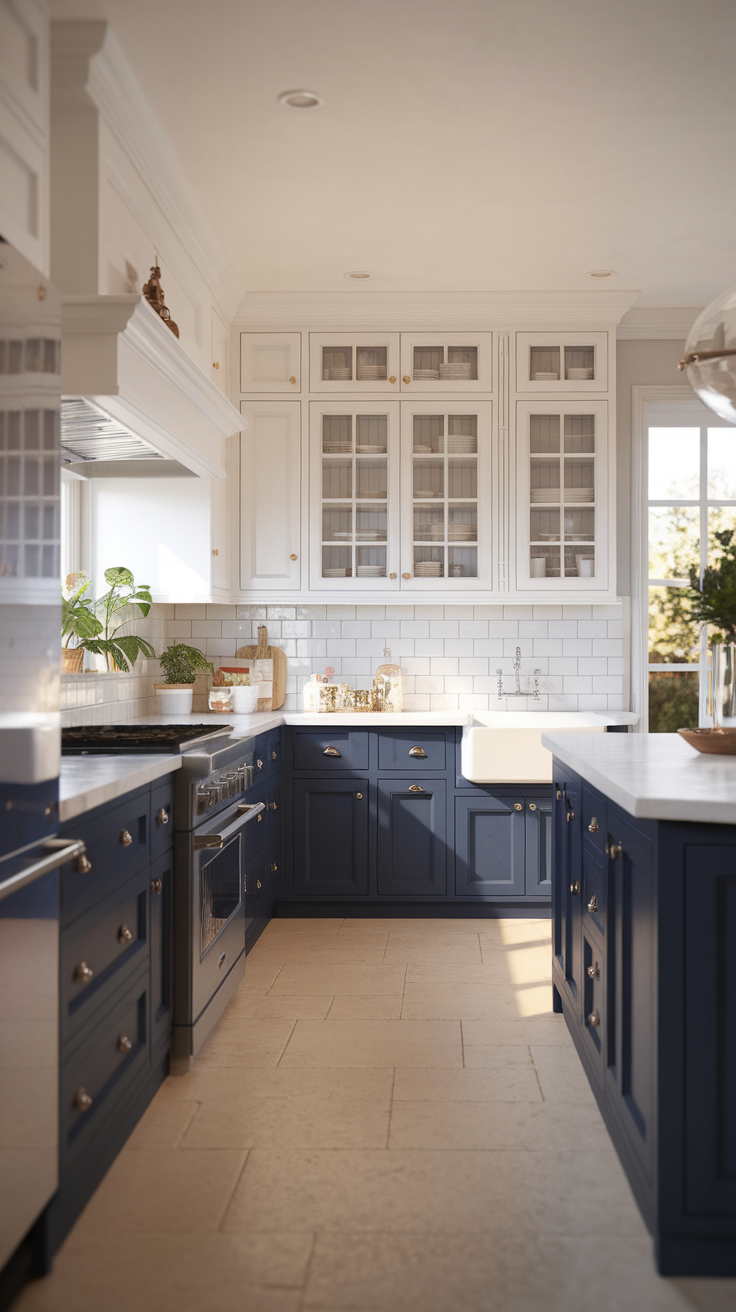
[401,332,493,396]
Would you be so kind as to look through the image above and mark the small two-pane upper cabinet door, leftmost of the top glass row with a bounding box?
[310,332,399,396]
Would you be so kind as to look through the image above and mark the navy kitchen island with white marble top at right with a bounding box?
[543,733,736,1275]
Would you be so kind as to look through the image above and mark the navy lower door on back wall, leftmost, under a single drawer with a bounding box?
[288,778,369,897]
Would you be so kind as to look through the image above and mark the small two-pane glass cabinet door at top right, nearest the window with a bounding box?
[516,332,609,395]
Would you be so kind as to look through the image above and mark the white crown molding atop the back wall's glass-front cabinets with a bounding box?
[234,290,639,332]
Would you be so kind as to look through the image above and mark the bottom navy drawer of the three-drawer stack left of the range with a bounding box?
[60,980,148,1160]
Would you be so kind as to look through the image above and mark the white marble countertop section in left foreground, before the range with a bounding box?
[59,754,181,823]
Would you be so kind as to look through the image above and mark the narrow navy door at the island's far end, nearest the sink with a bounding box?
[552,762,583,1021]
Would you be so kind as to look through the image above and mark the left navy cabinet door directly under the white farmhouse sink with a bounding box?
[455,794,526,900]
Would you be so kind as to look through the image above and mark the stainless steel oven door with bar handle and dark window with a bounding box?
[192,802,264,1023]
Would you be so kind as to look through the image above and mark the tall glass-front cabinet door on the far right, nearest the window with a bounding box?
[516,401,609,593]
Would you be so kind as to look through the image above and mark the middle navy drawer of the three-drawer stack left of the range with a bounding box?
[59,865,150,1043]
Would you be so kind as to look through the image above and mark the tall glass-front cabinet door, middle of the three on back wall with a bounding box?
[401,399,491,592]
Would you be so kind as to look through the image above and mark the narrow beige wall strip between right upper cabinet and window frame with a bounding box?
[617,340,685,597]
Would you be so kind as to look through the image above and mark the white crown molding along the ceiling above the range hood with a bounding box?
[51,20,243,321]
